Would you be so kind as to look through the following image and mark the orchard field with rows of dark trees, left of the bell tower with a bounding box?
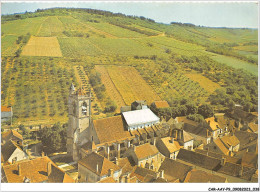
[1,57,76,122]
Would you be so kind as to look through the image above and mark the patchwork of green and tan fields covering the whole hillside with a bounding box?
[1,12,258,124]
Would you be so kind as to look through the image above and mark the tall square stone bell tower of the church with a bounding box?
[67,84,91,161]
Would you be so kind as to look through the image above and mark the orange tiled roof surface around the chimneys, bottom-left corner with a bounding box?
[3,156,74,183]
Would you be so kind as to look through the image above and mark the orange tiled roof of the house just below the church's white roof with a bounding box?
[135,143,159,160]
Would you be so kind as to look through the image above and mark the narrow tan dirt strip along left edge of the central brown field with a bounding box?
[96,65,126,113]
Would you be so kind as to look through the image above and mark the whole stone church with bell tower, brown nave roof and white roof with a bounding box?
[67,84,173,161]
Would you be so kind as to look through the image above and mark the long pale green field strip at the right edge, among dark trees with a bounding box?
[212,55,258,76]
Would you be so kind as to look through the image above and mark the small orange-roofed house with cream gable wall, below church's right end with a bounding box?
[156,137,182,160]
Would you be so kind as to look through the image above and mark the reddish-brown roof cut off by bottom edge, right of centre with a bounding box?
[184,169,227,183]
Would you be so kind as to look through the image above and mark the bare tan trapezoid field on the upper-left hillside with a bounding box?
[22,36,62,57]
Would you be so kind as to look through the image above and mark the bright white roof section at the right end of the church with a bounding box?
[122,109,160,126]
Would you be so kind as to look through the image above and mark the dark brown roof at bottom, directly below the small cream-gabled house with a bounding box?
[159,157,192,182]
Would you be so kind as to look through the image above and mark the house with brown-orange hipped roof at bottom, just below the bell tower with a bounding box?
[78,152,122,183]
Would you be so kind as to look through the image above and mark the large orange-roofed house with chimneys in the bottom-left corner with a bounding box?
[2,156,75,183]
